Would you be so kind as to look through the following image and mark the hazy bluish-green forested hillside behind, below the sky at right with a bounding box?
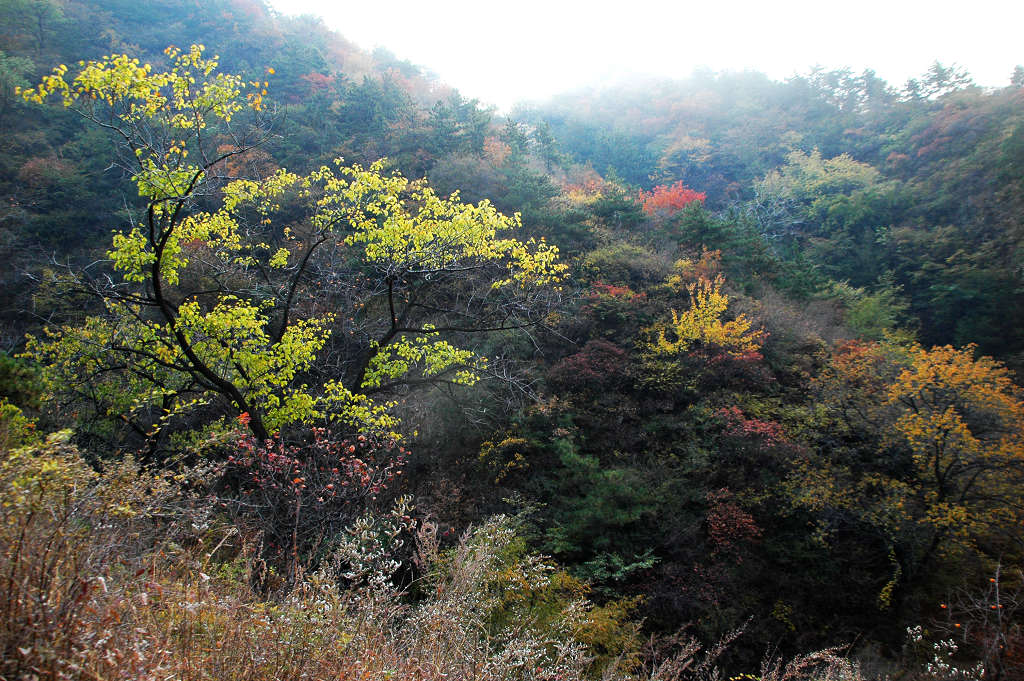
[523,68,1024,363]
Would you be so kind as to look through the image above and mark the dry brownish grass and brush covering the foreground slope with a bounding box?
[0,434,872,681]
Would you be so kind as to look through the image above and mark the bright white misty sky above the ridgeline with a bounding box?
[270,0,1024,109]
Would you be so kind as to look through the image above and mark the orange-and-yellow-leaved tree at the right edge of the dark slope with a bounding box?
[790,342,1024,602]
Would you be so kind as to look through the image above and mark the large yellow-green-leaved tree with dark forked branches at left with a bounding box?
[22,45,565,442]
